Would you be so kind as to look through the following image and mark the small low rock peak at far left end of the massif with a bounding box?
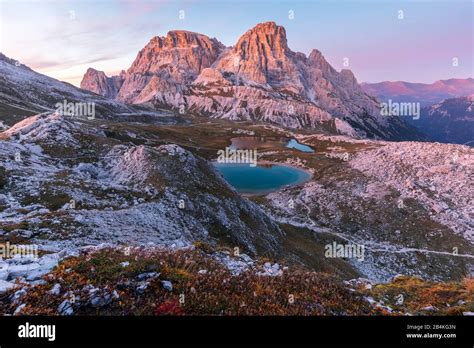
[81,68,125,98]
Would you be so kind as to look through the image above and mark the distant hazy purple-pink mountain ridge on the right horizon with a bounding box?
[361,78,474,106]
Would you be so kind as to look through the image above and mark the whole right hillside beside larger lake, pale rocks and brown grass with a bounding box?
[256,135,474,281]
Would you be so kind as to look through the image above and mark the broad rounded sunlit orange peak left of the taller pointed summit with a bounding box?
[117,30,224,103]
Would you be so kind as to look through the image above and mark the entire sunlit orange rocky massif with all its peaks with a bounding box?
[81,22,418,139]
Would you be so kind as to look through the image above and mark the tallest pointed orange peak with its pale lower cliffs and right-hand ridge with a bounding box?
[191,22,410,138]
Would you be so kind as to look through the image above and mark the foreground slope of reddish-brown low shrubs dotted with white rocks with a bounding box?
[0,244,474,316]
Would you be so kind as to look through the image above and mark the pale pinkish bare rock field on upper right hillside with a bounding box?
[350,142,474,243]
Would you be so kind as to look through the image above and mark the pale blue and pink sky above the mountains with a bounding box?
[0,0,474,86]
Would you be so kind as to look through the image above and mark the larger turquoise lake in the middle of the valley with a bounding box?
[214,163,311,194]
